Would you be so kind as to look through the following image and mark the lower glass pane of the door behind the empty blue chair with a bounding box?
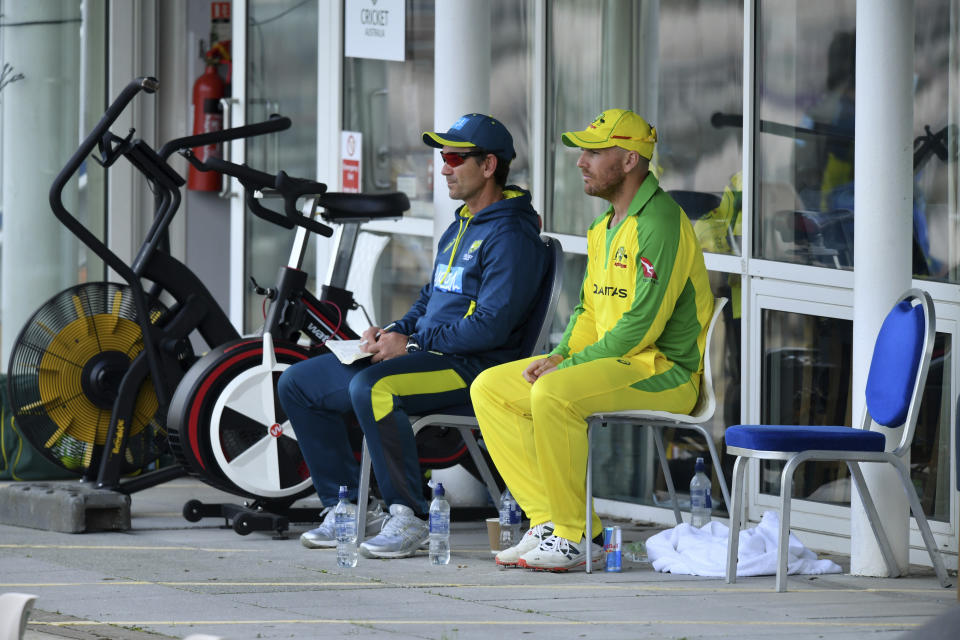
[760,310,951,520]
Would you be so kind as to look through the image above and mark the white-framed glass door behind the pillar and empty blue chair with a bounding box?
[745,0,960,552]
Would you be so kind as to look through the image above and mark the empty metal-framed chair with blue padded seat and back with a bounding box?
[726,289,949,592]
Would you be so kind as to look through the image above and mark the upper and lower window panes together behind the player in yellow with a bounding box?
[546,0,743,506]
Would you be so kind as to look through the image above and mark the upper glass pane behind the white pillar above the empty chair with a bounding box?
[755,0,958,281]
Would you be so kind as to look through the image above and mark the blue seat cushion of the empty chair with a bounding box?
[724,424,887,451]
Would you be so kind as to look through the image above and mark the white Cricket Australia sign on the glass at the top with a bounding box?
[343,0,407,62]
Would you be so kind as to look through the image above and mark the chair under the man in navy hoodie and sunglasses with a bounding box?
[357,235,563,532]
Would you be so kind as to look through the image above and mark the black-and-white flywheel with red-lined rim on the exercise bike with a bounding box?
[167,338,313,500]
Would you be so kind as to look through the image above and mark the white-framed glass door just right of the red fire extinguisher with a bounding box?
[229,0,318,333]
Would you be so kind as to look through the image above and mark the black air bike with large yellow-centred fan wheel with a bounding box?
[7,78,406,504]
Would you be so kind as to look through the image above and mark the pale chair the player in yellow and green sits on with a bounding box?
[586,298,730,573]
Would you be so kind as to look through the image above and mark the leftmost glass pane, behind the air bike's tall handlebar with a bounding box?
[0,0,108,356]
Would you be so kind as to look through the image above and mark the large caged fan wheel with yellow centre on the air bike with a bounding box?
[7,282,167,474]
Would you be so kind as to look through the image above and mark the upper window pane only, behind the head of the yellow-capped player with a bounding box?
[546,0,743,242]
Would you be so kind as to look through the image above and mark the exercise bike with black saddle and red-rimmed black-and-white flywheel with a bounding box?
[167,151,409,533]
